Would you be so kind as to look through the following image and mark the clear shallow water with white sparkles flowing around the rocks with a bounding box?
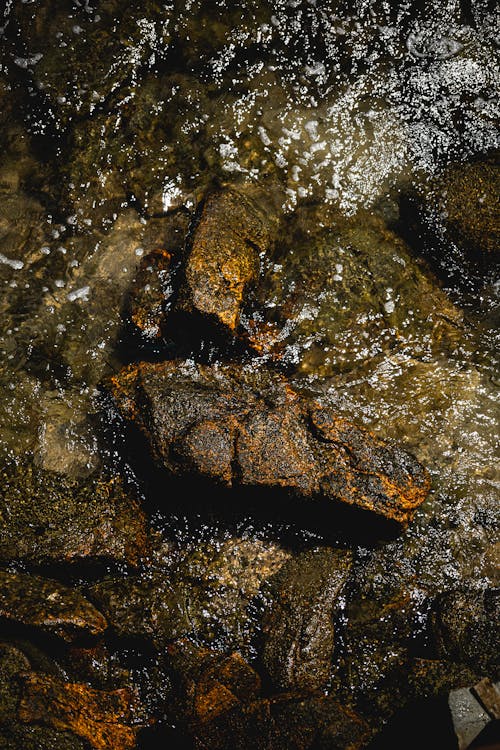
[0,0,500,748]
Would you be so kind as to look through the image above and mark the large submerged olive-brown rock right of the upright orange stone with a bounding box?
[246,205,462,378]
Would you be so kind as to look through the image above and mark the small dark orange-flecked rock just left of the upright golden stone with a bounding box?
[127,249,173,341]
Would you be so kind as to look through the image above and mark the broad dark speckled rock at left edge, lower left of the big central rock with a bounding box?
[0,461,148,565]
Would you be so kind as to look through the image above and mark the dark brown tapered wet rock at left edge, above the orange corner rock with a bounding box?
[0,571,107,641]
